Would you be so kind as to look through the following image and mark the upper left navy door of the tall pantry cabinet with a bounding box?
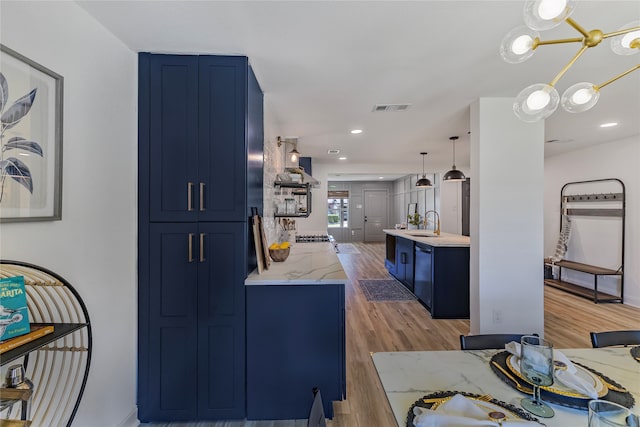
[146,55,200,222]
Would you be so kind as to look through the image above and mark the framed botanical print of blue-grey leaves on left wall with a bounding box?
[0,44,63,222]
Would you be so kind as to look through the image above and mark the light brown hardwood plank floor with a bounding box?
[142,243,640,427]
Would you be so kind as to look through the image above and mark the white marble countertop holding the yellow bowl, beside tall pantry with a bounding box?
[244,242,347,286]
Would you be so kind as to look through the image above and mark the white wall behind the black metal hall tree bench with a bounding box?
[544,135,640,307]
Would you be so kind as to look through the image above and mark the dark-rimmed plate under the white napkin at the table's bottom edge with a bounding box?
[407,391,544,427]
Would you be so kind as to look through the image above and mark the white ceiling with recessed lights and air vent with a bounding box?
[78,0,640,180]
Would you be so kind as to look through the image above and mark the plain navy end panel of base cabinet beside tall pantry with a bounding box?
[246,283,346,420]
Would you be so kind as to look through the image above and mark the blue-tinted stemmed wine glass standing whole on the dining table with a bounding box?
[520,335,554,418]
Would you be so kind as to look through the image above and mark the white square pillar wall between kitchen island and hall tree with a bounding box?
[469,98,544,334]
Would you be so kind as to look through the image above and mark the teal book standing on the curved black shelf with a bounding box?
[0,276,30,340]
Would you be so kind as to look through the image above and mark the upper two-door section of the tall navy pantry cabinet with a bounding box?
[141,54,255,222]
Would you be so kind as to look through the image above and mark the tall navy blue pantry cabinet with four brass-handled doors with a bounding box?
[138,53,263,421]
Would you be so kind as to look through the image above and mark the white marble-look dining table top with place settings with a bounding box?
[371,347,640,427]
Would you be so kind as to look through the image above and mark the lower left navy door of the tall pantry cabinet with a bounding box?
[138,223,198,421]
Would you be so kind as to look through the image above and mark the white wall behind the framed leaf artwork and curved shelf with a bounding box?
[0,1,137,427]
